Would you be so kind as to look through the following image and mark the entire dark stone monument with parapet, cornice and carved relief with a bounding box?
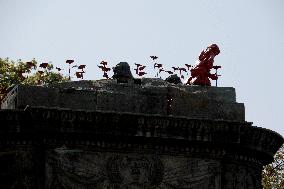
[0,63,283,189]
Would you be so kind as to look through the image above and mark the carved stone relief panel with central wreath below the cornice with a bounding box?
[46,147,220,189]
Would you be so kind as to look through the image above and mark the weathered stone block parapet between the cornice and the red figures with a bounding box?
[2,79,245,121]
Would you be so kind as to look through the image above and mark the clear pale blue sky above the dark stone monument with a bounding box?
[0,0,284,135]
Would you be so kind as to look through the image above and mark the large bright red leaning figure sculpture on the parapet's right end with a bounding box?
[186,44,220,86]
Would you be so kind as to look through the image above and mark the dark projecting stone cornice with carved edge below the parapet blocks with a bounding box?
[0,107,283,164]
